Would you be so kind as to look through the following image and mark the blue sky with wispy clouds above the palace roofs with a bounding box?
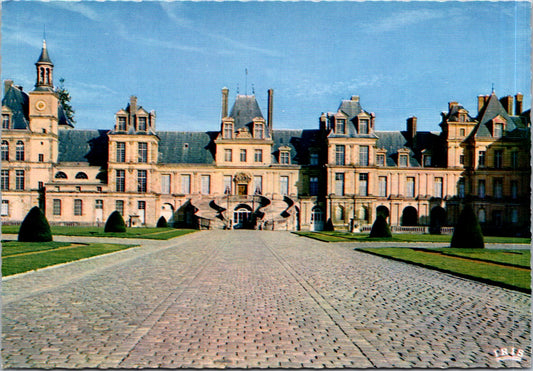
[1,1,531,131]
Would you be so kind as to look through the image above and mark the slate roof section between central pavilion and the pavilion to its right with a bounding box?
[272,130,320,165]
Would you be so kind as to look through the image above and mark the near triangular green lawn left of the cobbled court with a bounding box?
[2,241,135,277]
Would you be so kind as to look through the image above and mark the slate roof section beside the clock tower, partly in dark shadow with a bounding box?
[58,130,108,166]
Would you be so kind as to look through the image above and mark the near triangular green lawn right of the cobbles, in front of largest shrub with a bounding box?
[357,247,531,293]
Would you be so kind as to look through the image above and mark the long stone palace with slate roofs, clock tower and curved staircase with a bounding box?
[1,44,531,233]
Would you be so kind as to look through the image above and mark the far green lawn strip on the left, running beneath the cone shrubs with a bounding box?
[2,225,196,240]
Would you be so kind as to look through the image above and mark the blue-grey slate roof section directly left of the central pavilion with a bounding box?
[157,131,218,164]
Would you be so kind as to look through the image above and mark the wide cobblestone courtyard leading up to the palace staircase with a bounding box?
[2,231,531,368]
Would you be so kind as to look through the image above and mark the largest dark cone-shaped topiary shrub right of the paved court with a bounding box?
[450,204,485,249]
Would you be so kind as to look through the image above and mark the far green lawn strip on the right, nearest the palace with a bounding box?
[294,231,531,244]
